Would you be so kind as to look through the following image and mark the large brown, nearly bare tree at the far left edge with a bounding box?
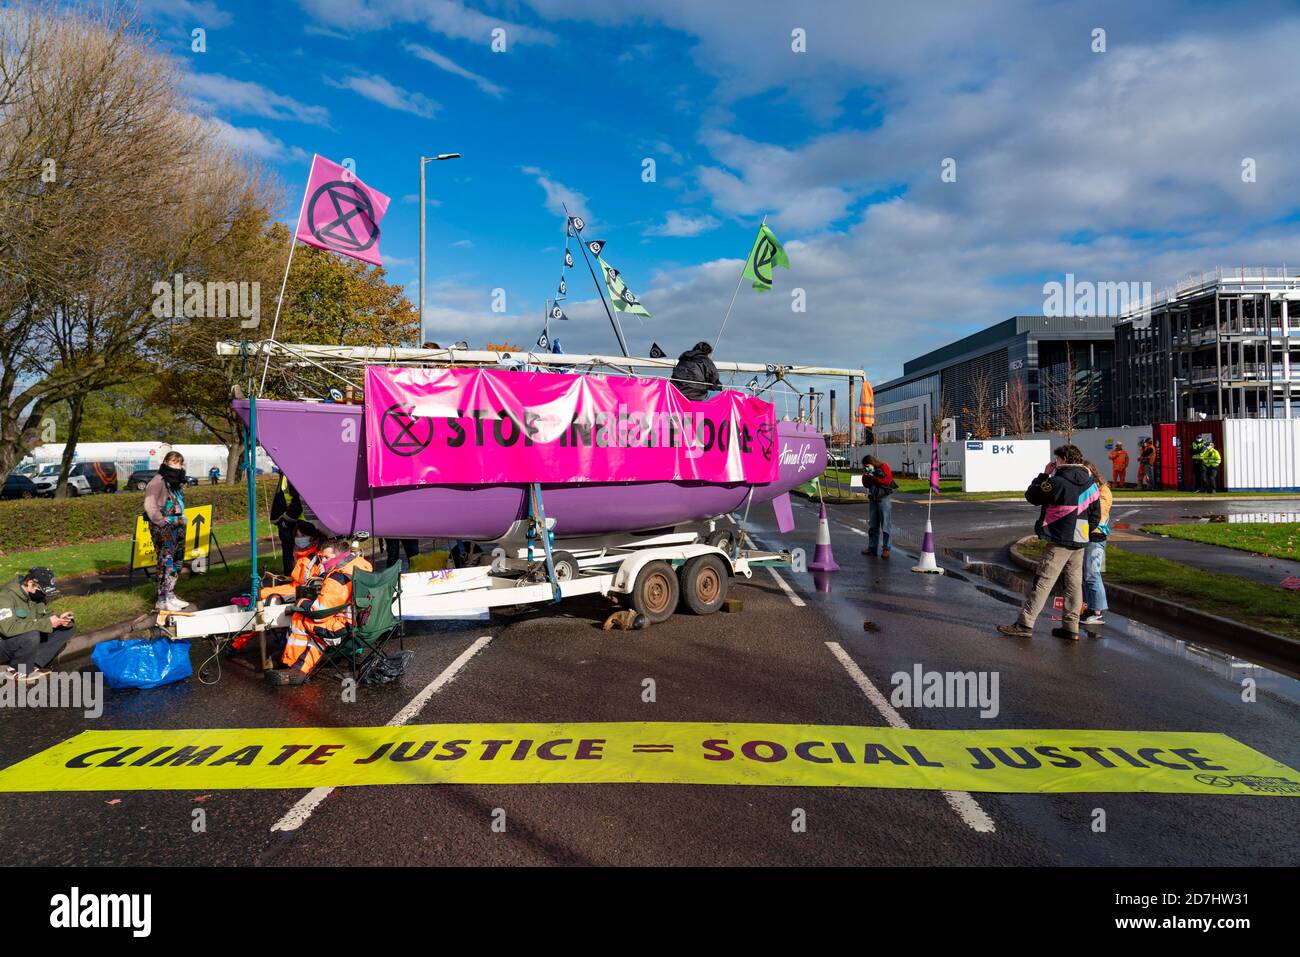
[0,3,253,473]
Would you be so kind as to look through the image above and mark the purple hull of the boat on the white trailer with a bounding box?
[234,400,826,541]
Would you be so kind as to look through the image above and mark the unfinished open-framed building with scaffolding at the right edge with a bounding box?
[1114,267,1300,425]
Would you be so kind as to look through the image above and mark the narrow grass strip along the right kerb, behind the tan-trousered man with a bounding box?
[1023,541,1300,638]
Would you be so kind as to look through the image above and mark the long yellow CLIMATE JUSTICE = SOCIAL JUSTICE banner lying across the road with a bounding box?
[0,723,1300,797]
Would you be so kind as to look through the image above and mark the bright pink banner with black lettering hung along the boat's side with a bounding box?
[365,365,780,488]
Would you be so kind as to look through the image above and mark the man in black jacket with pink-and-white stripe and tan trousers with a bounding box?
[997,445,1101,641]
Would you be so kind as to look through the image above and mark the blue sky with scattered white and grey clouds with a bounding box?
[142,0,1300,382]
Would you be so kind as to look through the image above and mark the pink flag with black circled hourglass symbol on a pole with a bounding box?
[294,156,389,265]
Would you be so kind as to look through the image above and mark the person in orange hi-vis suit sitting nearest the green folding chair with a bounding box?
[267,538,372,684]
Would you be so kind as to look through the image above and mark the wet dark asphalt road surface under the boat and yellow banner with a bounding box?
[0,501,1300,866]
